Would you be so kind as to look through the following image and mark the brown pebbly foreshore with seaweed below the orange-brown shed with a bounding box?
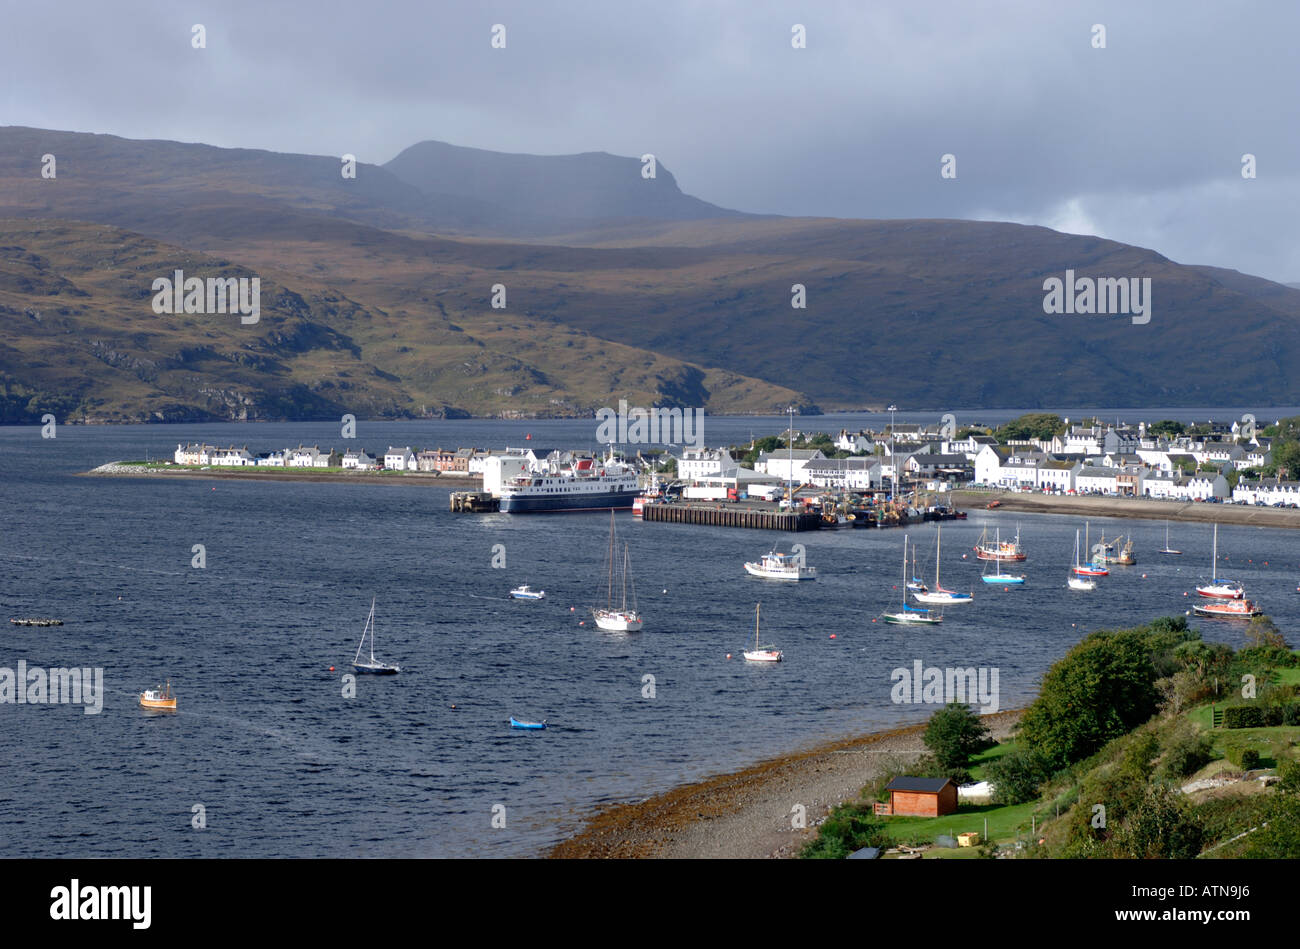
[545,709,1024,859]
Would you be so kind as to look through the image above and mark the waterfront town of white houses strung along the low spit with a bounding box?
[173,410,1300,507]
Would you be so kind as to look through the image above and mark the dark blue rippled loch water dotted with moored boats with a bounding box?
[0,411,1300,857]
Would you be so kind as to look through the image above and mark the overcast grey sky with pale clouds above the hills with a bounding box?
[0,0,1300,282]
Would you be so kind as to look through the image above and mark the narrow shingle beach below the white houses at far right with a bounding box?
[952,490,1300,529]
